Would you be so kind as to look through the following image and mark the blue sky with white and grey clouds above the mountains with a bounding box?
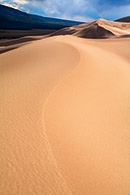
[0,0,130,22]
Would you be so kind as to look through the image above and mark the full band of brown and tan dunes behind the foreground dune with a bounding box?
[0,17,130,54]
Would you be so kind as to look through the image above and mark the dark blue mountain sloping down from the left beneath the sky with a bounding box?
[0,5,82,30]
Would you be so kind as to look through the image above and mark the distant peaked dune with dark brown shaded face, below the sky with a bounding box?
[52,19,130,39]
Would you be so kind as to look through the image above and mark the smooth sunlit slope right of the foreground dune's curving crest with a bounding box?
[44,37,130,195]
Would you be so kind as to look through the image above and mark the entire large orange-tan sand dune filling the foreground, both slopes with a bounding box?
[0,36,130,195]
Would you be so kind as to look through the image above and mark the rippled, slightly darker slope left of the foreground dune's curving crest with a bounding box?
[0,38,79,195]
